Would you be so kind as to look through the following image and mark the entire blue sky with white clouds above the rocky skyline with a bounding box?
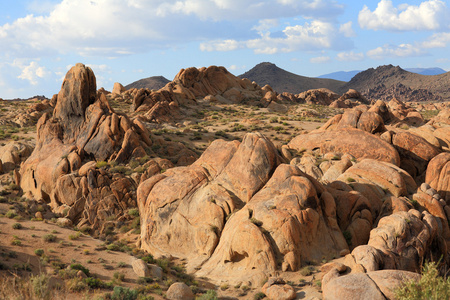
[0,0,450,99]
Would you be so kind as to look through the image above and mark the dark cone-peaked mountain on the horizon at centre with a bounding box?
[238,62,345,94]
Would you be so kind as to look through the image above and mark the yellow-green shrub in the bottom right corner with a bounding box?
[395,262,450,300]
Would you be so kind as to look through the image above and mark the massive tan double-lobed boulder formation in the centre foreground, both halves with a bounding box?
[137,134,348,284]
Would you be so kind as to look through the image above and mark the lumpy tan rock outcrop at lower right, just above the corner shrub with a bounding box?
[345,209,447,272]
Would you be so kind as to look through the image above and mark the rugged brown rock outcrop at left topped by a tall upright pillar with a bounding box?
[20,64,192,232]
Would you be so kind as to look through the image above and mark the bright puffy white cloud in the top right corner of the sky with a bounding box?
[358,0,450,31]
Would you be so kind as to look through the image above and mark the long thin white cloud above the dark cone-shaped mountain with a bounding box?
[200,20,352,54]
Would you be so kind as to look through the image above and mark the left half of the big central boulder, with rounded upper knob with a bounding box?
[137,133,281,267]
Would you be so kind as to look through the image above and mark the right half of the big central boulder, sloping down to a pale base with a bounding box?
[197,164,347,284]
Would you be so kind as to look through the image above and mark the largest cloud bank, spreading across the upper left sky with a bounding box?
[0,0,343,57]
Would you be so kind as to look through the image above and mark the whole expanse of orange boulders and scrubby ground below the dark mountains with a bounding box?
[0,64,450,300]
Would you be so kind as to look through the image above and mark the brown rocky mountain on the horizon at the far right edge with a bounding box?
[338,65,450,101]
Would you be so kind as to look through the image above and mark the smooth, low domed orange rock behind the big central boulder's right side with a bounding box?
[288,128,400,166]
